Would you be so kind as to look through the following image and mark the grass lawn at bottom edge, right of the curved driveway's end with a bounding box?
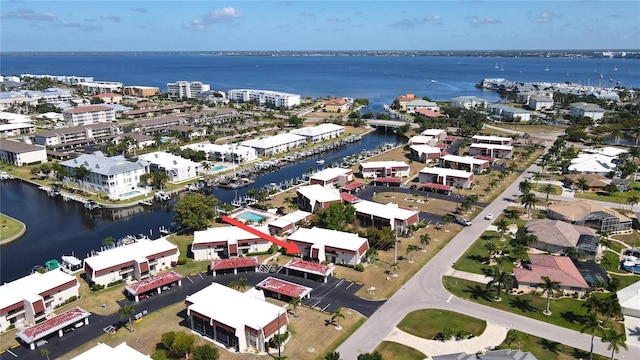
[498,330,608,360]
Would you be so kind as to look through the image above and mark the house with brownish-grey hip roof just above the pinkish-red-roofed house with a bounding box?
[526,219,600,260]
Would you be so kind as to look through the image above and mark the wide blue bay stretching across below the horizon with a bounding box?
[0,54,640,111]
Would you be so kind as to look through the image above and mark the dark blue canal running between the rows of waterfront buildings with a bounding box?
[0,131,396,283]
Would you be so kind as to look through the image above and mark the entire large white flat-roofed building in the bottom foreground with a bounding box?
[185,282,289,353]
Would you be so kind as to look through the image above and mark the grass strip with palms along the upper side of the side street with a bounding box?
[443,276,624,332]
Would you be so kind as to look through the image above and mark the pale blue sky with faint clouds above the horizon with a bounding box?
[0,0,640,52]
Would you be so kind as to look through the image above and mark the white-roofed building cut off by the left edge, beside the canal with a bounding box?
[0,268,80,332]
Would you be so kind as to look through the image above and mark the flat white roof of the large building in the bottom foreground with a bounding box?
[186,282,286,332]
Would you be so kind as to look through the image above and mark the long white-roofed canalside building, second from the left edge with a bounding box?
[83,238,180,286]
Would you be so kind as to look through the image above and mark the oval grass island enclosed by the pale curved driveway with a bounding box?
[398,309,487,339]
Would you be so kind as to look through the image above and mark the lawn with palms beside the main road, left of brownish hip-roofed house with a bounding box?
[453,231,515,275]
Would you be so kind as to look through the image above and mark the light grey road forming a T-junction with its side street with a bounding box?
[337,165,640,359]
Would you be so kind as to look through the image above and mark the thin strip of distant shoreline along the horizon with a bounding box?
[0,49,640,59]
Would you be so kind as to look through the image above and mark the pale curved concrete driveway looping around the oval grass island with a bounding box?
[384,323,509,357]
